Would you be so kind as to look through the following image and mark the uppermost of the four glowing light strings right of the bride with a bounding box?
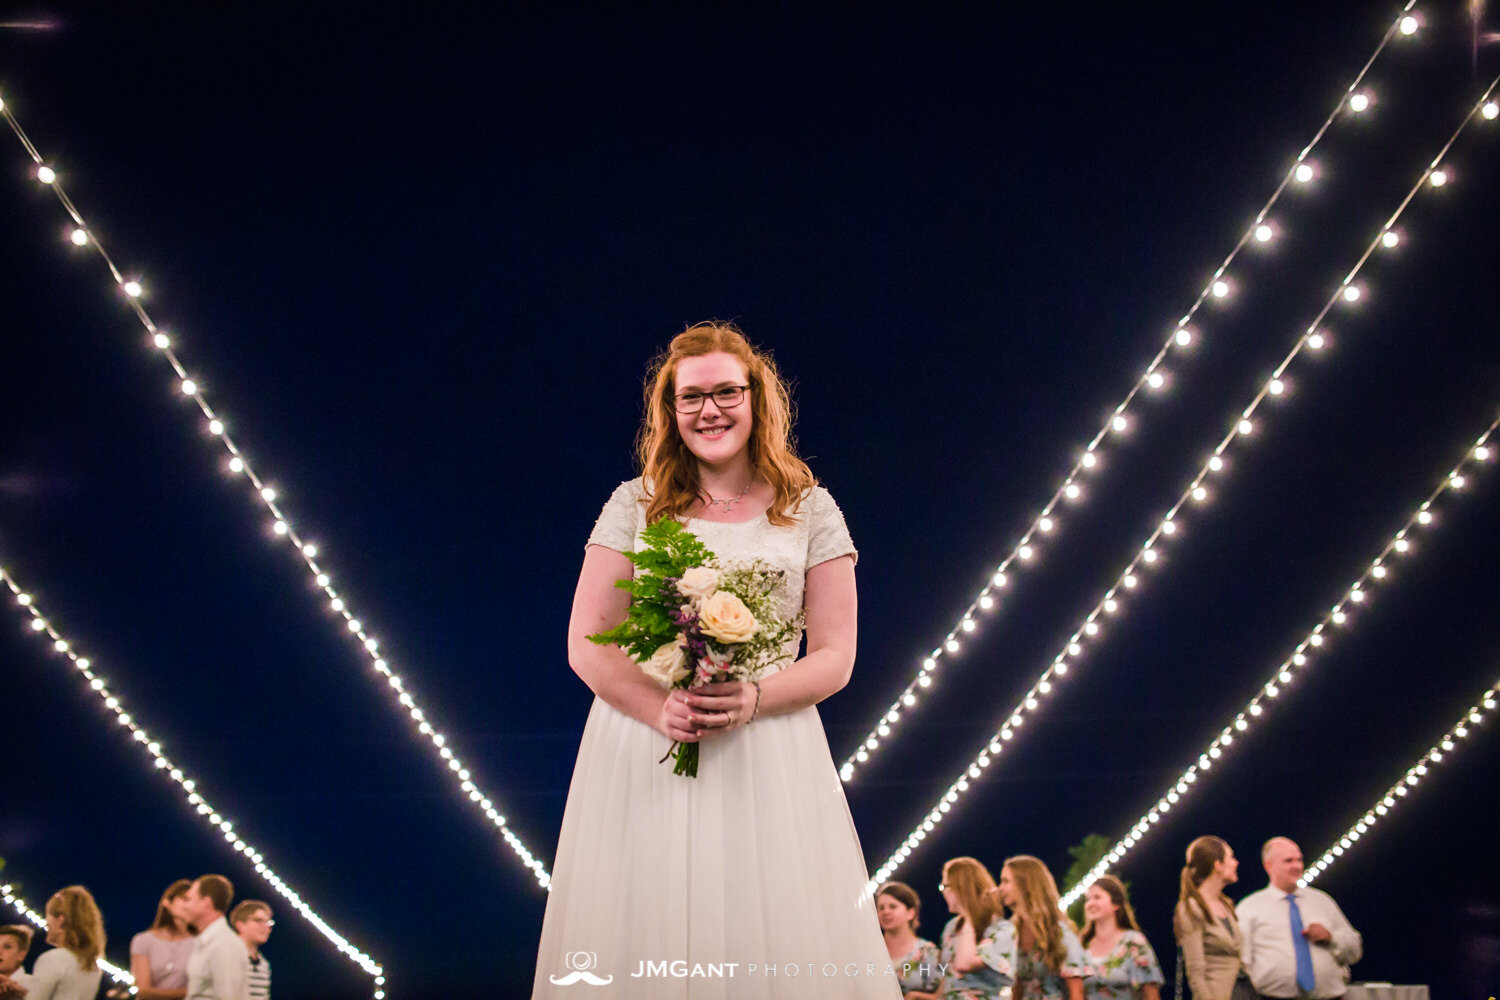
[839,0,1419,781]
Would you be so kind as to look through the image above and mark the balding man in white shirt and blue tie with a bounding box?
[1235,837,1364,1000]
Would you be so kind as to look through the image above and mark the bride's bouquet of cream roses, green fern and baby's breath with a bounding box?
[590,517,801,778]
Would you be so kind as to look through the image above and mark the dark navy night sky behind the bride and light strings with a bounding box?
[0,0,1500,1000]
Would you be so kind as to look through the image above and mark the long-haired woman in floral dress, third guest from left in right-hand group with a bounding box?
[980,855,1091,1000]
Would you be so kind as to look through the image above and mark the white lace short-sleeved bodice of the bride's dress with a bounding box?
[588,478,860,661]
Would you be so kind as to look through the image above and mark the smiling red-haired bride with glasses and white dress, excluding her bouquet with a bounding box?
[533,324,900,1000]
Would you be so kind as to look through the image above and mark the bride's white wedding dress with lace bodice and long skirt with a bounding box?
[531,480,902,1000]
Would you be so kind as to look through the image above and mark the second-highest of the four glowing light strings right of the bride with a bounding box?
[873,76,1500,883]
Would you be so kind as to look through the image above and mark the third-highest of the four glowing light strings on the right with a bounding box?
[1062,417,1500,909]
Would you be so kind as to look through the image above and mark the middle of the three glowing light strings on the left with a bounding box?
[0,567,386,1000]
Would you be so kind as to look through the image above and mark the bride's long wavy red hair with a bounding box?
[636,321,818,526]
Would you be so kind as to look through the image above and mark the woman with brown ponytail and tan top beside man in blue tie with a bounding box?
[1172,837,1254,1000]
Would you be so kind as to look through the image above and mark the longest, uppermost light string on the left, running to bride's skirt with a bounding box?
[0,100,552,889]
